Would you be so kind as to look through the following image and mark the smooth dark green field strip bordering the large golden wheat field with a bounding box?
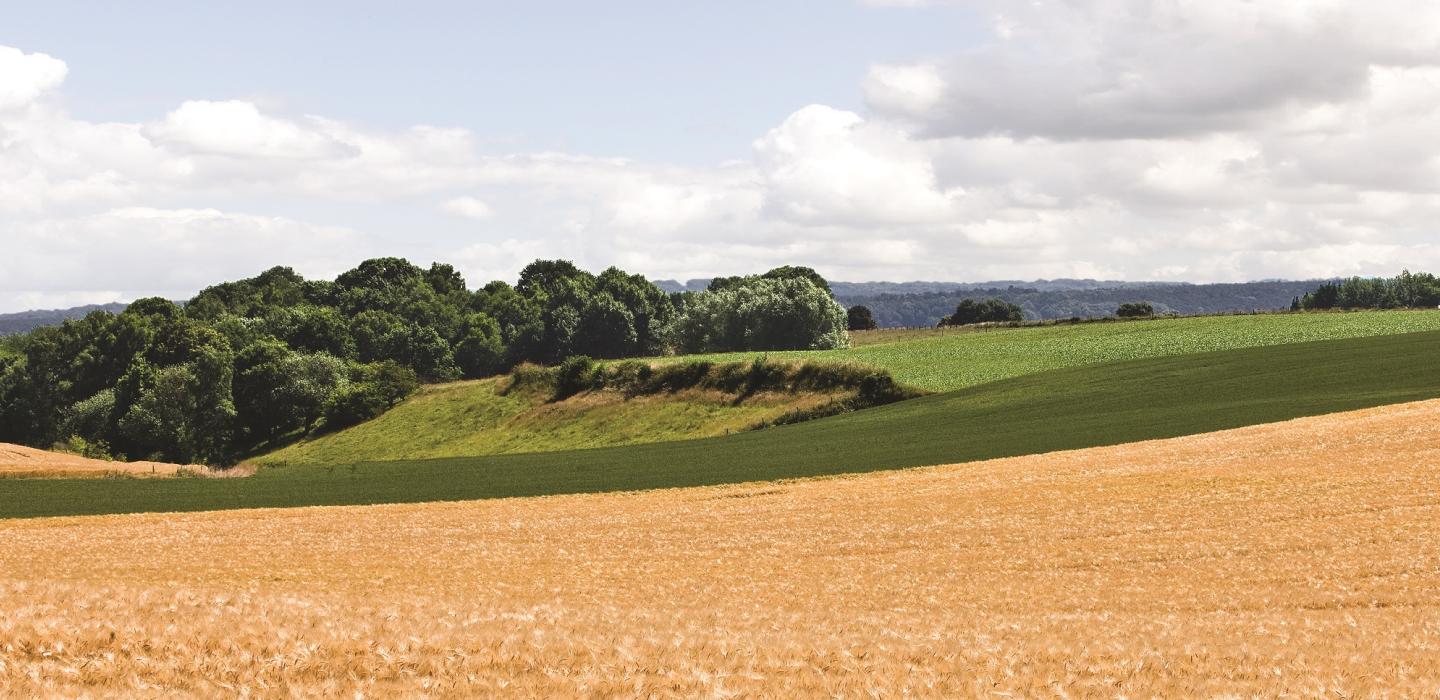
[0,333,1440,517]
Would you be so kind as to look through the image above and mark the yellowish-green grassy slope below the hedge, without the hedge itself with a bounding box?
[252,377,838,467]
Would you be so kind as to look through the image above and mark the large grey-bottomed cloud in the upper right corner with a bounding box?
[867,0,1440,138]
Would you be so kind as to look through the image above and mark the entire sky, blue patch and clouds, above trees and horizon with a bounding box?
[0,0,1440,311]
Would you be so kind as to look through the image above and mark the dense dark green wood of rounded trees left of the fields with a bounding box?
[0,258,850,464]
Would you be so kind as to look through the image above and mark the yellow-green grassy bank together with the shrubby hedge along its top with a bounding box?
[251,362,913,467]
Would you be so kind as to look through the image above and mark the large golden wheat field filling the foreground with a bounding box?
[0,402,1440,697]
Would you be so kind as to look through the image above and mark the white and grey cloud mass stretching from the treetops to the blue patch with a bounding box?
[0,0,1440,311]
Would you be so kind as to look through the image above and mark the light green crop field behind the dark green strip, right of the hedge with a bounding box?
[655,310,1440,392]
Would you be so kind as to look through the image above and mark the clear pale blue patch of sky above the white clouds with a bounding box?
[0,0,985,166]
